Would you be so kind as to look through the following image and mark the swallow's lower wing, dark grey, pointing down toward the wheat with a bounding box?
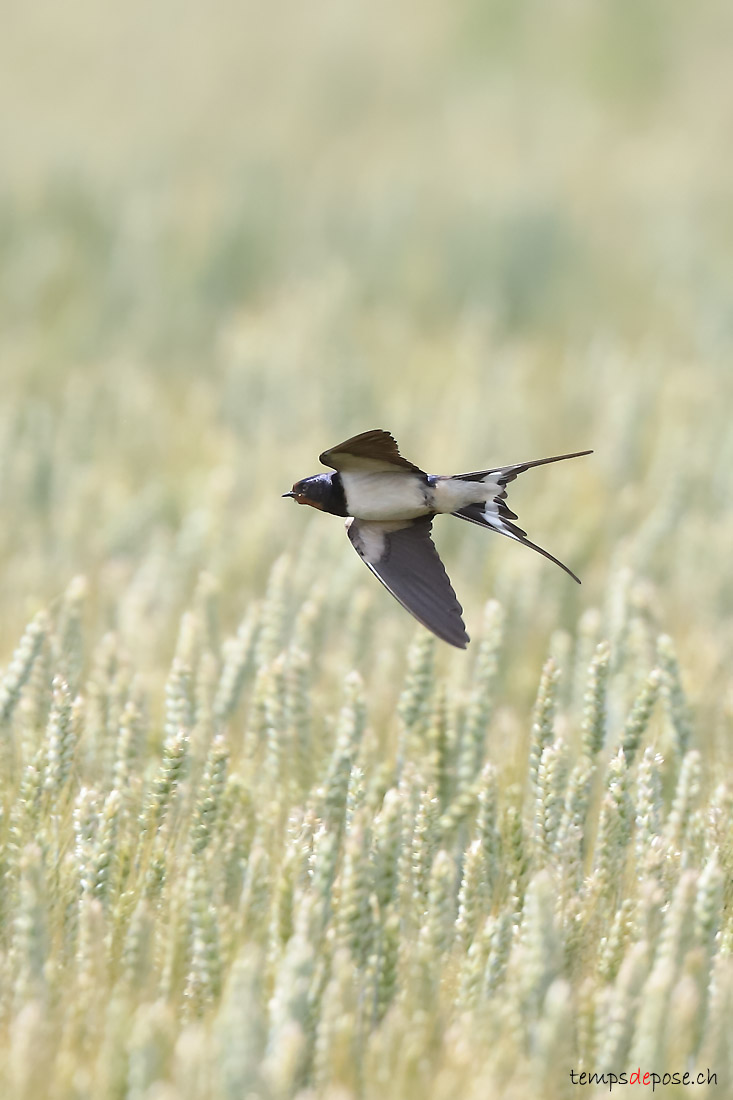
[347,516,469,649]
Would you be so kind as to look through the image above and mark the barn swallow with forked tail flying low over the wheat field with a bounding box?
[283,429,592,649]
